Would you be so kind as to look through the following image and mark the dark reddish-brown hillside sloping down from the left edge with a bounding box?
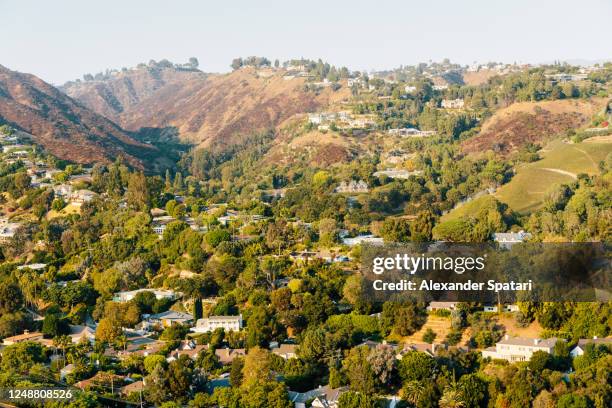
[0,65,155,168]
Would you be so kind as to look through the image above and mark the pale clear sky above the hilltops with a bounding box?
[0,0,612,84]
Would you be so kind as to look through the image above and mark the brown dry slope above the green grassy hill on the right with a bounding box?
[463,98,605,153]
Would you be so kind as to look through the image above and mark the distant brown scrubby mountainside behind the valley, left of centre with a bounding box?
[64,67,349,147]
